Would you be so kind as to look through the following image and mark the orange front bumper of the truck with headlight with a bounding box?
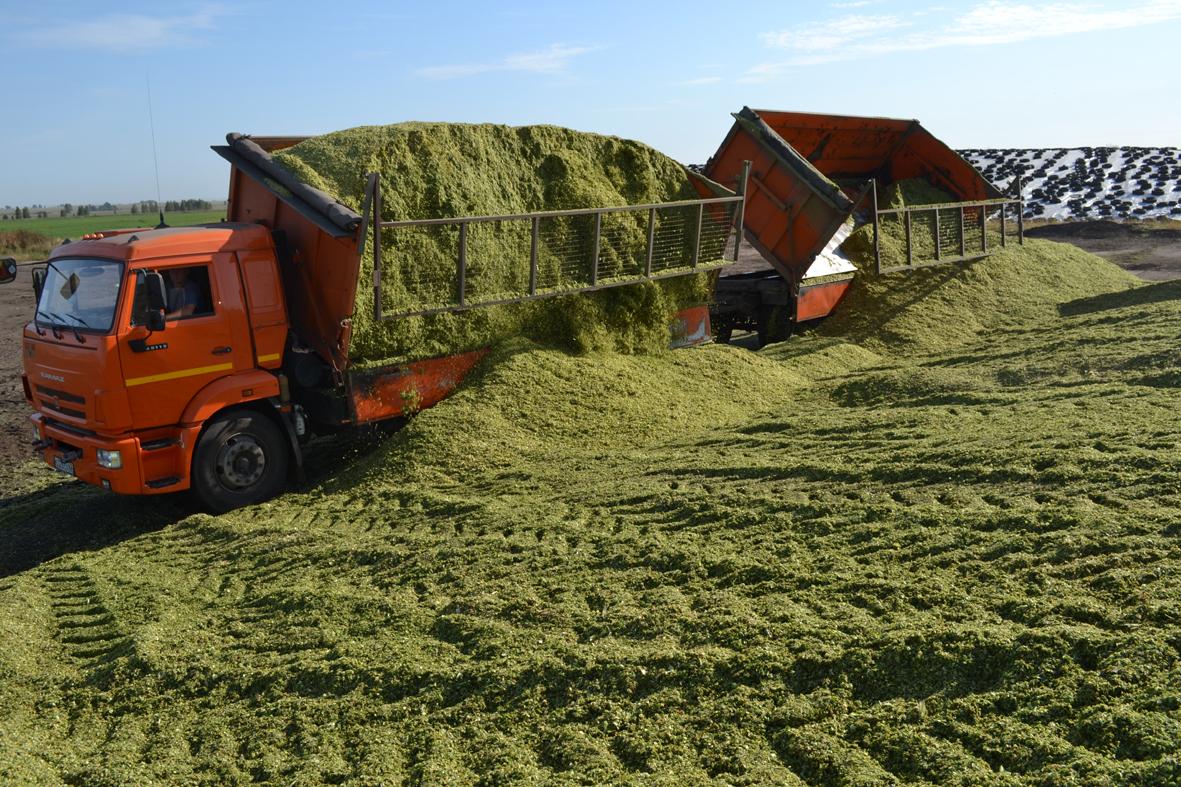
[31,412,200,495]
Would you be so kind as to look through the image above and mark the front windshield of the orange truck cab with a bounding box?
[35,258,123,333]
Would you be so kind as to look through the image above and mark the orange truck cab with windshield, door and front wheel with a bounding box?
[24,223,295,509]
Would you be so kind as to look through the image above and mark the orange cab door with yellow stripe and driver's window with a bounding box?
[119,254,248,429]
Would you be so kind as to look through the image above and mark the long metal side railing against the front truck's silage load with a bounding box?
[360,168,745,320]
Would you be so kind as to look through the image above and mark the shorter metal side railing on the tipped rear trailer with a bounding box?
[869,180,1025,274]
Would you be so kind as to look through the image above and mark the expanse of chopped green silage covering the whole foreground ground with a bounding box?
[0,233,1181,786]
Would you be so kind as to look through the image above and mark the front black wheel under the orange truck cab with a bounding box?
[191,409,291,514]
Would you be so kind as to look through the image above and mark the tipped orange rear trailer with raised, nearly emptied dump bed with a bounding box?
[704,108,1019,343]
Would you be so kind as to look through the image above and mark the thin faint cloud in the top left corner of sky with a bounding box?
[17,6,228,53]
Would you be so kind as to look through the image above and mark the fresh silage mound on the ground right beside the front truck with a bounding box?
[341,339,808,489]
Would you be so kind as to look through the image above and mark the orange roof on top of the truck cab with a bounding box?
[50,222,270,262]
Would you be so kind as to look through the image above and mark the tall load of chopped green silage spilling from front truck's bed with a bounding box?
[275,123,720,364]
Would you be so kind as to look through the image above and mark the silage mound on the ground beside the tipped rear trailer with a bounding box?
[818,239,1138,355]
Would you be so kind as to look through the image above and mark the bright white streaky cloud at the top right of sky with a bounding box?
[742,0,1181,74]
